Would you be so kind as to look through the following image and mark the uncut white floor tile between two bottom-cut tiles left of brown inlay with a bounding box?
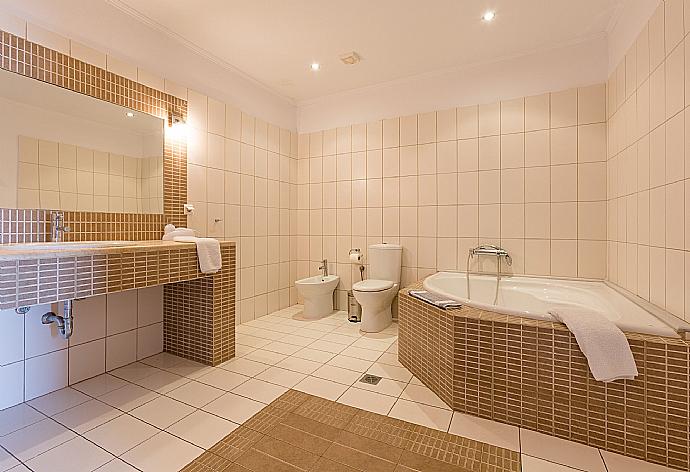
[84,415,158,456]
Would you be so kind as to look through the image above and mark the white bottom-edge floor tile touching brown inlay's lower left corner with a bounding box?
[122,432,204,472]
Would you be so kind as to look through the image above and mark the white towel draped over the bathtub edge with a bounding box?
[549,306,638,382]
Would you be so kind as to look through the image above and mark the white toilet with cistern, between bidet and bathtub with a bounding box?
[352,243,402,333]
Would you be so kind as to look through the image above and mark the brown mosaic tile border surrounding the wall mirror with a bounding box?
[0,30,187,232]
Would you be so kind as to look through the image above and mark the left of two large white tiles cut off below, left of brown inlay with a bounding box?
[26,437,115,472]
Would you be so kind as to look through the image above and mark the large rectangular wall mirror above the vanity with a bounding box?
[0,70,164,213]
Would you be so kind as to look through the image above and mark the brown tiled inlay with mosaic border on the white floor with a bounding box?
[183,390,520,472]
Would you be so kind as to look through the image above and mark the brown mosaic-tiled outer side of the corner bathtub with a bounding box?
[399,289,690,470]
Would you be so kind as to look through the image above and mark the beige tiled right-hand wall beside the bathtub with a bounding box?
[607,0,690,320]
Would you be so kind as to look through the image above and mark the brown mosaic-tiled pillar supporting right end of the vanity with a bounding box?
[163,243,236,366]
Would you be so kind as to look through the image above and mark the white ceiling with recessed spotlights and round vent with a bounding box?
[105,0,623,103]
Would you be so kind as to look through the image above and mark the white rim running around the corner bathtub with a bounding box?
[423,270,690,339]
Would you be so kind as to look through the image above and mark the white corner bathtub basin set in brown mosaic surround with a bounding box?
[424,272,678,338]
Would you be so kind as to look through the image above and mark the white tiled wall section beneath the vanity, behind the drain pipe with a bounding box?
[0,287,163,410]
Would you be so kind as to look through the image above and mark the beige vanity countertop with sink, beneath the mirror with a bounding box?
[0,240,235,261]
